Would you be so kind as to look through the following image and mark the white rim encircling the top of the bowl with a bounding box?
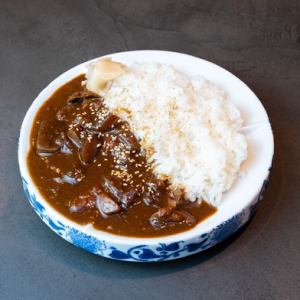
[18,50,274,246]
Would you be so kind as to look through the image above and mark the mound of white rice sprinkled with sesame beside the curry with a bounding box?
[101,63,247,206]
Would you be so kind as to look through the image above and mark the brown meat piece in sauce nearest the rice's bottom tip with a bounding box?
[149,207,196,228]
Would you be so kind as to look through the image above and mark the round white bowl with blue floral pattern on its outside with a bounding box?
[18,50,274,262]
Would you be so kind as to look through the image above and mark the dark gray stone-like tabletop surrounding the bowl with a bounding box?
[0,0,300,300]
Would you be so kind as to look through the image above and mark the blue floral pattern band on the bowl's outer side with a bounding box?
[22,178,268,262]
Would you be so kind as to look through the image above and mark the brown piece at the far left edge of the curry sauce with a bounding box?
[36,121,61,156]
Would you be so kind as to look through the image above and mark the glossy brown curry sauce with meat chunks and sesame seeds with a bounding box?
[27,75,216,237]
